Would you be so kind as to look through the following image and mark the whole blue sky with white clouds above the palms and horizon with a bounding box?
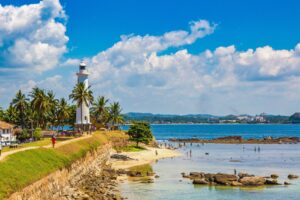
[0,0,300,115]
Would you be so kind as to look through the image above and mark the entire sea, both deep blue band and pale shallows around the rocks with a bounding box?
[119,124,300,200]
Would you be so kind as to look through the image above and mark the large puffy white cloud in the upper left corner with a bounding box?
[0,0,68,73]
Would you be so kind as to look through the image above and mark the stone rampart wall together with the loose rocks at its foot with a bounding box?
[9,144,120,200]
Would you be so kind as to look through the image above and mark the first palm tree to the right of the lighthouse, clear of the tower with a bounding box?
[91,96,109,125]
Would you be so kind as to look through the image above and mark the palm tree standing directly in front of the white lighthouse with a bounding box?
[69,83,94,129]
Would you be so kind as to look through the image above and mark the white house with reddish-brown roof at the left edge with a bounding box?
[0,121,16,146]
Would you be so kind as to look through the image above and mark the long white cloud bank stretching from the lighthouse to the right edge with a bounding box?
[82,21,300,114]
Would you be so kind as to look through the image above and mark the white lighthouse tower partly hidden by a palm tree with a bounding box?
[75,62,91,130]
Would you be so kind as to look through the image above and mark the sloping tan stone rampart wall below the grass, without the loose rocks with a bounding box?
[8,144,111,200]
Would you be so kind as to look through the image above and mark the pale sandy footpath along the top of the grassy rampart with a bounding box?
[0,135,92,161]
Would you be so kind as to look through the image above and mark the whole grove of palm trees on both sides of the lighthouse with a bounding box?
[0,83,124,134]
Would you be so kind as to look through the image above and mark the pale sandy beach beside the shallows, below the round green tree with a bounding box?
[111,147,181,169]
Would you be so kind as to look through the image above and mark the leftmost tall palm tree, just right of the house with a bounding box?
[11,90,28,128]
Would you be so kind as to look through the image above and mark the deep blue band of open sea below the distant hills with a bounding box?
[121,124,300,140]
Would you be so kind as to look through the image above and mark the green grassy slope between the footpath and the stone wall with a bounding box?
[0,133,107,199]
